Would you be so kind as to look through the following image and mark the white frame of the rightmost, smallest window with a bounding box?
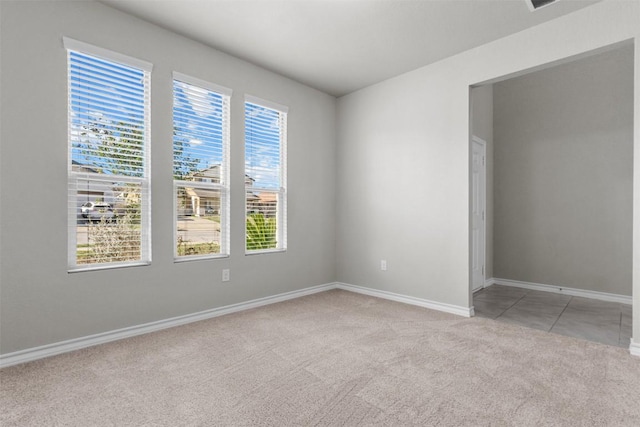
[244,94,289,255]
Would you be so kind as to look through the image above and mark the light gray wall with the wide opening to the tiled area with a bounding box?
[337,1,640,342]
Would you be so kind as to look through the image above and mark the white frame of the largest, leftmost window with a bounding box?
[62,37,153,273]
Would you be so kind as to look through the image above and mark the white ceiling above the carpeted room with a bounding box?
[101,0,599,96]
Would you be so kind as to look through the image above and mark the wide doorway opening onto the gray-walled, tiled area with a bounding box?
[469,43,634,347]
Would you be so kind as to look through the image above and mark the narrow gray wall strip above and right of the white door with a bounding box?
[471,84,493,279]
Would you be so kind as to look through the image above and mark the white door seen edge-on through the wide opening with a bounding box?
[471,136,486,291]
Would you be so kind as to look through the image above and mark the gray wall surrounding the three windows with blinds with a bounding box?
[0,1,336,354]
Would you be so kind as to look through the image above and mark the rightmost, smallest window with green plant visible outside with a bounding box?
[245,96,287,253]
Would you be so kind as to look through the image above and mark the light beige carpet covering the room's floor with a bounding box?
[0,290,640,427]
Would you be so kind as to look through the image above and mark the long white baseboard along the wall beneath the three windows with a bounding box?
[0,283,336,368]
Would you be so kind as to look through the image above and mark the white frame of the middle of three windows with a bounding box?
[171,71,233,262]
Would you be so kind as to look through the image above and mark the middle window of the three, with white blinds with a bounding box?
[173,73,231,260]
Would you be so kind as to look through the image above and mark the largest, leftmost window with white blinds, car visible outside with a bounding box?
[64,38,151,271]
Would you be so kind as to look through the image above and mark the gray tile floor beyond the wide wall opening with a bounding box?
[473,285,631,348]
